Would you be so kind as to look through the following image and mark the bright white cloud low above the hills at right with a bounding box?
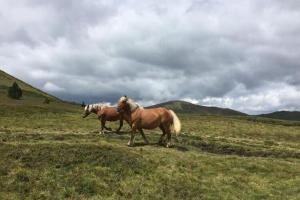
[200,84,300,114]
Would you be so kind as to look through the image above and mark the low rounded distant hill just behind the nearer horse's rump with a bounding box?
[149,101,246,116]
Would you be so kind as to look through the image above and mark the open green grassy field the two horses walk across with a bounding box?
[0,100,300,199]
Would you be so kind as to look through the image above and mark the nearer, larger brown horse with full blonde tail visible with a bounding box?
[118,96,181,147]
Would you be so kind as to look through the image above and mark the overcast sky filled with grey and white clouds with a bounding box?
[0,0,300,114]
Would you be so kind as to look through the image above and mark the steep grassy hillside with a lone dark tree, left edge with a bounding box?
[0,70,79,111]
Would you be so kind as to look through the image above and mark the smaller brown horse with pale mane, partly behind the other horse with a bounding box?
[82,103,123,134]
